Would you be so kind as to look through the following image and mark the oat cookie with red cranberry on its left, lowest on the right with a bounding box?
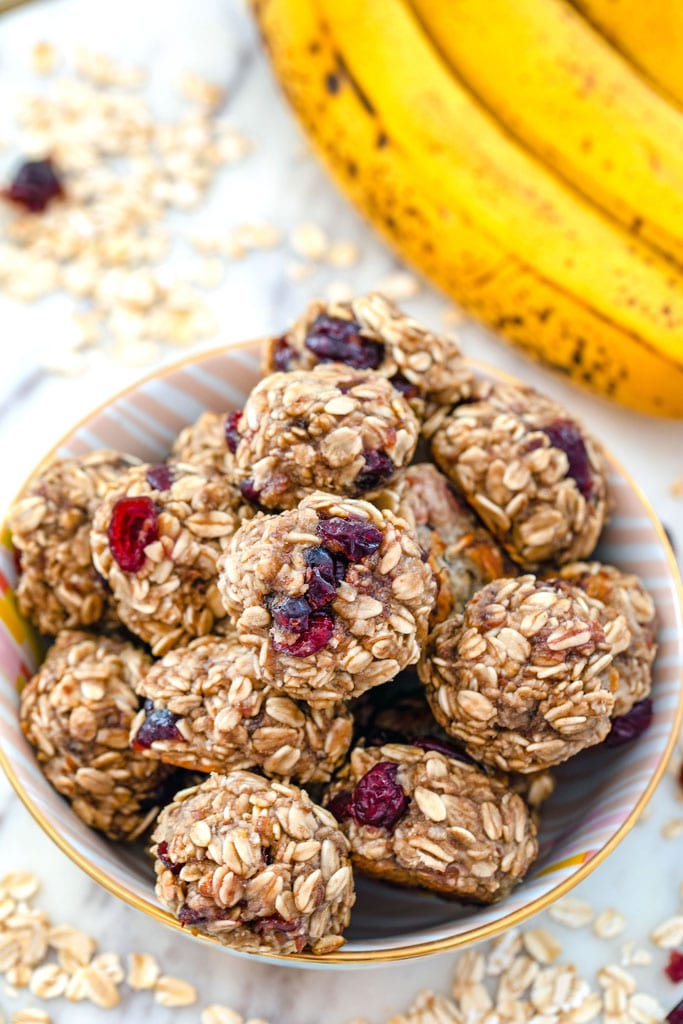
[325,743,538,903]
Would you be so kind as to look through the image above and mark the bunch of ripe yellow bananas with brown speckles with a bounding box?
[252,0,683,417]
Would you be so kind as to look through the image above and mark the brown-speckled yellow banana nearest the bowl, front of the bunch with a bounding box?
[253,0,683,417]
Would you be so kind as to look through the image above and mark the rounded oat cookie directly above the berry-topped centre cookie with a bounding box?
[228,364,418,509]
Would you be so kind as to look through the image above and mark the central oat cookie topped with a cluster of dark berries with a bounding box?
[218,492,435,707]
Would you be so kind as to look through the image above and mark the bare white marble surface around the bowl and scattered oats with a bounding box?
[0,0,683,1024]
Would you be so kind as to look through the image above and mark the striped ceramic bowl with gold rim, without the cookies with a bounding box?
[0,342,683,966]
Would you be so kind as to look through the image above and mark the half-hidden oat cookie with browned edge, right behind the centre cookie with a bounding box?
[394,462,518,626]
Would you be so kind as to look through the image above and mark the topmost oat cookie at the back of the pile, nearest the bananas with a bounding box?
[264,293,472,419]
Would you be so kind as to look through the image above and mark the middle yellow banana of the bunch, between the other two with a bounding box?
[411,0,683,264]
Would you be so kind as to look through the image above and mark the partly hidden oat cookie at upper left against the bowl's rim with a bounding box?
[7,451,137,636]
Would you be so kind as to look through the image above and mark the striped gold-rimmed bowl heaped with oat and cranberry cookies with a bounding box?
[0,295,683,966]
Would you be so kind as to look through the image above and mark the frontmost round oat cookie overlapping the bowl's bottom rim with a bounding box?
[152,771,355,954]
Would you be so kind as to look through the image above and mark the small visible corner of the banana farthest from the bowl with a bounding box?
[571,0,683,105]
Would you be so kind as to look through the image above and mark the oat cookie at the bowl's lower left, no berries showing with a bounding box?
[19,630,172,841]
